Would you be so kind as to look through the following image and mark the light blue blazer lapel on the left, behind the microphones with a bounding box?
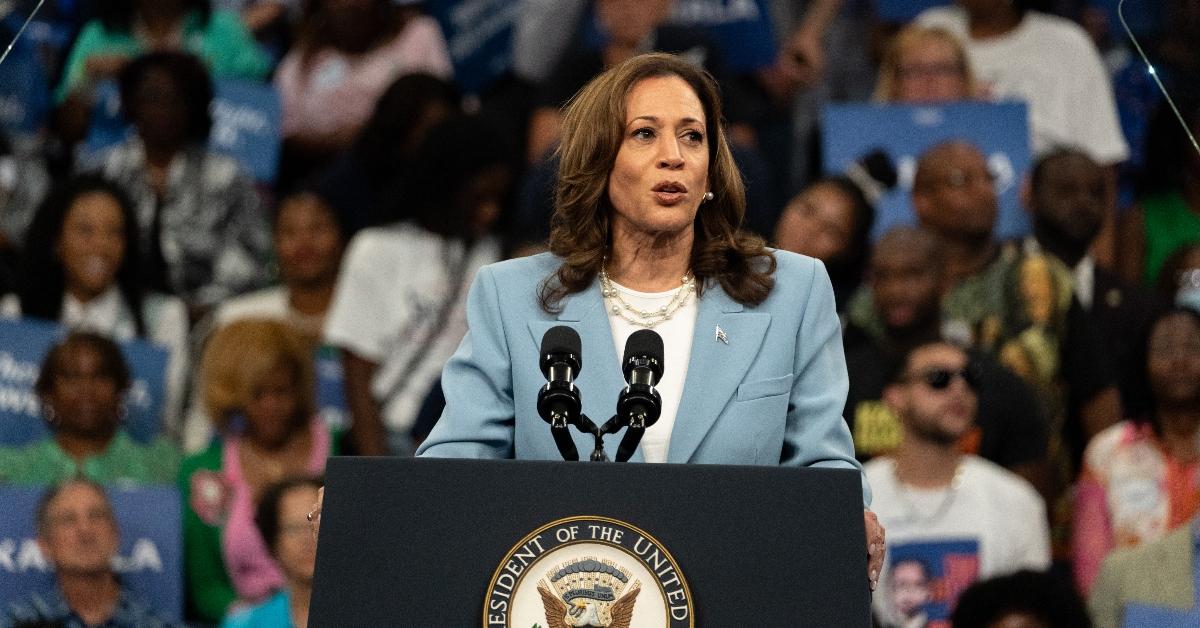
[529,281,644,462]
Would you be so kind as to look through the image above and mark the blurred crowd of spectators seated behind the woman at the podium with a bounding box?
[0,0,1200,628]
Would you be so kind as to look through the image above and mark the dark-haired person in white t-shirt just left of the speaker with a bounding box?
[325,116,512,455]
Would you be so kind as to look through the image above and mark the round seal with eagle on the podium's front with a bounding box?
[482,516,695,628]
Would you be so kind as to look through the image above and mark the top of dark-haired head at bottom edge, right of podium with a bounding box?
[950,570,1094,628]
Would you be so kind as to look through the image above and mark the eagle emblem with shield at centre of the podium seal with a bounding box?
[538,558,642,628]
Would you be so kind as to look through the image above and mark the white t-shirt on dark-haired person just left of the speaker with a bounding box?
[325,223,500,432]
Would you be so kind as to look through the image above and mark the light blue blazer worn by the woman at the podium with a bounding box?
[418,251,870,503]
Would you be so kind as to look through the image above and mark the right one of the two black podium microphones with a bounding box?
[617,329,664,462]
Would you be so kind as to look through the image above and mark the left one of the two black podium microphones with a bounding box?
[538,325,583,460]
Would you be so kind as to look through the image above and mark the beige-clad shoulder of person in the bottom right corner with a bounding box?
[1087,519,1200,628]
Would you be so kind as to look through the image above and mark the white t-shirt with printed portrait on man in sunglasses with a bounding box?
[864,455,1050,626]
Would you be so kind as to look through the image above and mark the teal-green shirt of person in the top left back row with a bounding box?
[54,11,271,102]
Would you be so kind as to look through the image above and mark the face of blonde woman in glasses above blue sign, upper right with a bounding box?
[896,38,971,103]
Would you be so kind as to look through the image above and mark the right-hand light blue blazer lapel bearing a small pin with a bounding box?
[666,283,770,462]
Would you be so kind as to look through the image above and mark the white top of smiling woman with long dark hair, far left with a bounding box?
[0,286,188,441]
